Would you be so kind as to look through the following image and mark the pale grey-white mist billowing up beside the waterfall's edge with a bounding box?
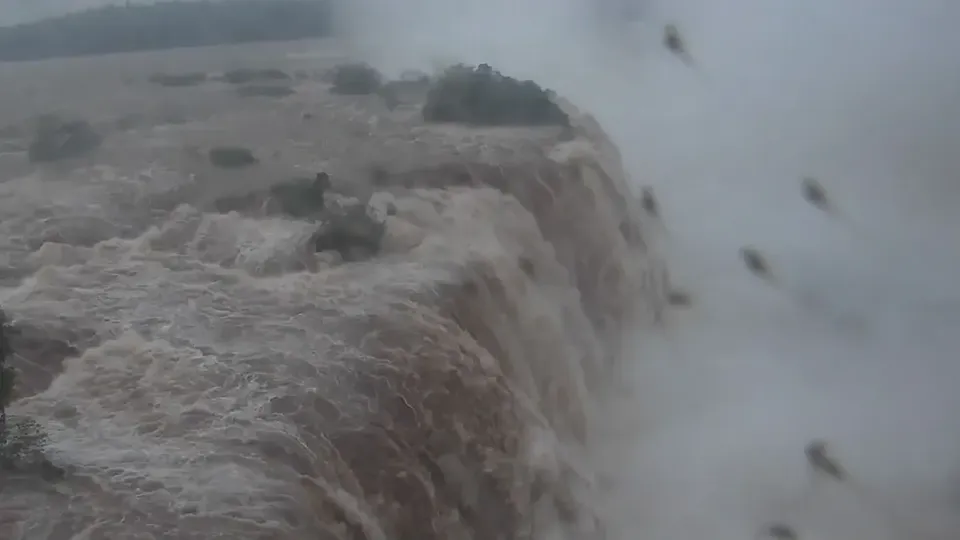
[332,0,960,540]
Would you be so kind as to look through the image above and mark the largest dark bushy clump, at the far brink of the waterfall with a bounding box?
[423,64,570,126]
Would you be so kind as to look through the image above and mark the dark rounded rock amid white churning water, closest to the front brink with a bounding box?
[313,204,386,261]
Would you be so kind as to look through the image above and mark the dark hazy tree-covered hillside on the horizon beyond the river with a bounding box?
[0,0,331,62]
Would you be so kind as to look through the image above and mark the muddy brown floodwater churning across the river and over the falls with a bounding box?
[0,42,666,540]
